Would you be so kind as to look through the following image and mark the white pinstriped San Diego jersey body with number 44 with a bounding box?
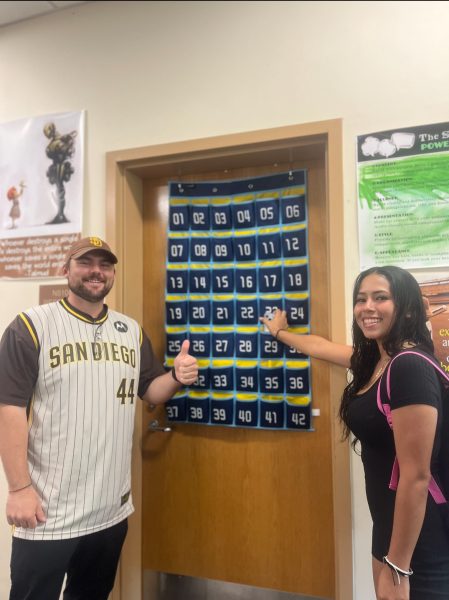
[14,300,142,540]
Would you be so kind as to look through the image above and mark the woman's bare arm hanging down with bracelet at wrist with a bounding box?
[378,404,438,600]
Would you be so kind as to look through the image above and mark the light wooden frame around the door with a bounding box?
[106,119,353,600]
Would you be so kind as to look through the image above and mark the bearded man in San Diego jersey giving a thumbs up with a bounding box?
[0,238,198,600]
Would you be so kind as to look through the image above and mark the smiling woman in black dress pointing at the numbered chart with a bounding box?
[261,266,449,600]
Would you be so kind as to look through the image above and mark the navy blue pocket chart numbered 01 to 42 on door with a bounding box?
[165,170,313,431]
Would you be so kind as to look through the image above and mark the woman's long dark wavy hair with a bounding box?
[339,266,433,439]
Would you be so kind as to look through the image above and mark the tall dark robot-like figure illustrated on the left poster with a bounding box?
[44,123,77,224]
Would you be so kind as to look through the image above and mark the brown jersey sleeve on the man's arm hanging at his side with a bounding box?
[0,315,39,406]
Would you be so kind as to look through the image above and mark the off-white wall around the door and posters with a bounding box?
[0,1,449,600]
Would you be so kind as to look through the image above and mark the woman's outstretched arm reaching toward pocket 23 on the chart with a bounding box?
[260,309,352,368]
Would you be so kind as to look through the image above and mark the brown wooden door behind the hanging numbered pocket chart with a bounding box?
[142,158,336,598]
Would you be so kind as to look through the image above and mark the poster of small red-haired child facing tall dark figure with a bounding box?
[0,111,85,278]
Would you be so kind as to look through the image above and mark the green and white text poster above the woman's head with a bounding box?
[357,123,449,270]
